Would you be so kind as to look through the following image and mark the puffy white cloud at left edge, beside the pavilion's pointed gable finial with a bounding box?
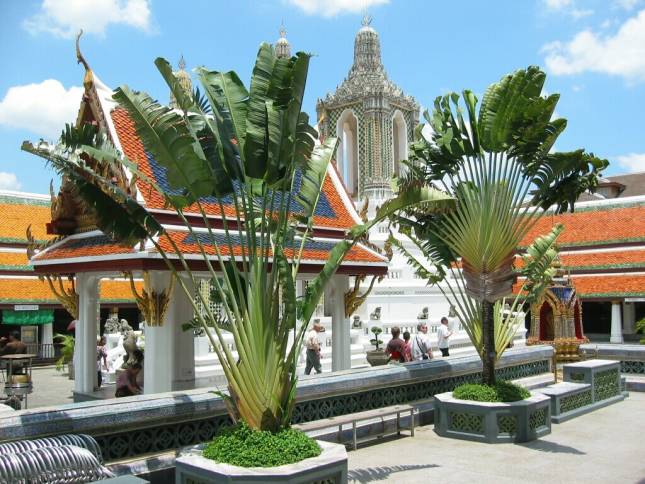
[0,79,83,139]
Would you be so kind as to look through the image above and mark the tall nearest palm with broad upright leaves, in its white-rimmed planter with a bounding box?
[23,40,454,482]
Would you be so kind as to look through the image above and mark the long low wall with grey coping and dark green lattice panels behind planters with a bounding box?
[0,346,553,462]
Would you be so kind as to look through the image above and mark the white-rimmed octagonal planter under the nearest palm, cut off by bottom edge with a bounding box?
[175,441,347,484]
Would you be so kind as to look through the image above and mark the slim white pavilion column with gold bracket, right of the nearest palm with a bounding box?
[325,274,352,371]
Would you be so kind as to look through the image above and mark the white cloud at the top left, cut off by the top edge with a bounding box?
[23,0,151,38]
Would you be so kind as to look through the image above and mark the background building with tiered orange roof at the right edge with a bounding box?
[522,194,645,343]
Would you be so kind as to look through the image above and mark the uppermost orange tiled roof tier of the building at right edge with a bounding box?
[520,203,645,247]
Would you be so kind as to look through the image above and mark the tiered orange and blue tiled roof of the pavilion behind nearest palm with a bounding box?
[31,67,387,274]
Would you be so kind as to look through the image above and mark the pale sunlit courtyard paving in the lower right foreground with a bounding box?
[349,392,645,484]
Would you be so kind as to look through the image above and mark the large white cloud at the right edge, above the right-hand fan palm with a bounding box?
[542,10,645,81]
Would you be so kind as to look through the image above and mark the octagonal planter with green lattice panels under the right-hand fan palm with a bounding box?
[434,392,551,444]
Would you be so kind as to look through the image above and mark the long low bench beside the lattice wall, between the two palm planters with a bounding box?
[294,405,415,450]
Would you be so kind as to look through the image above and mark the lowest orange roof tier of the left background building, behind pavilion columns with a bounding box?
[0,278,142,304]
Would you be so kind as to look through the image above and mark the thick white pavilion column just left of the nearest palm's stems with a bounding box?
[143,271,195,395]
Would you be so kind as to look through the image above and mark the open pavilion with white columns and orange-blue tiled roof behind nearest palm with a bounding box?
[26,43,387,399]
